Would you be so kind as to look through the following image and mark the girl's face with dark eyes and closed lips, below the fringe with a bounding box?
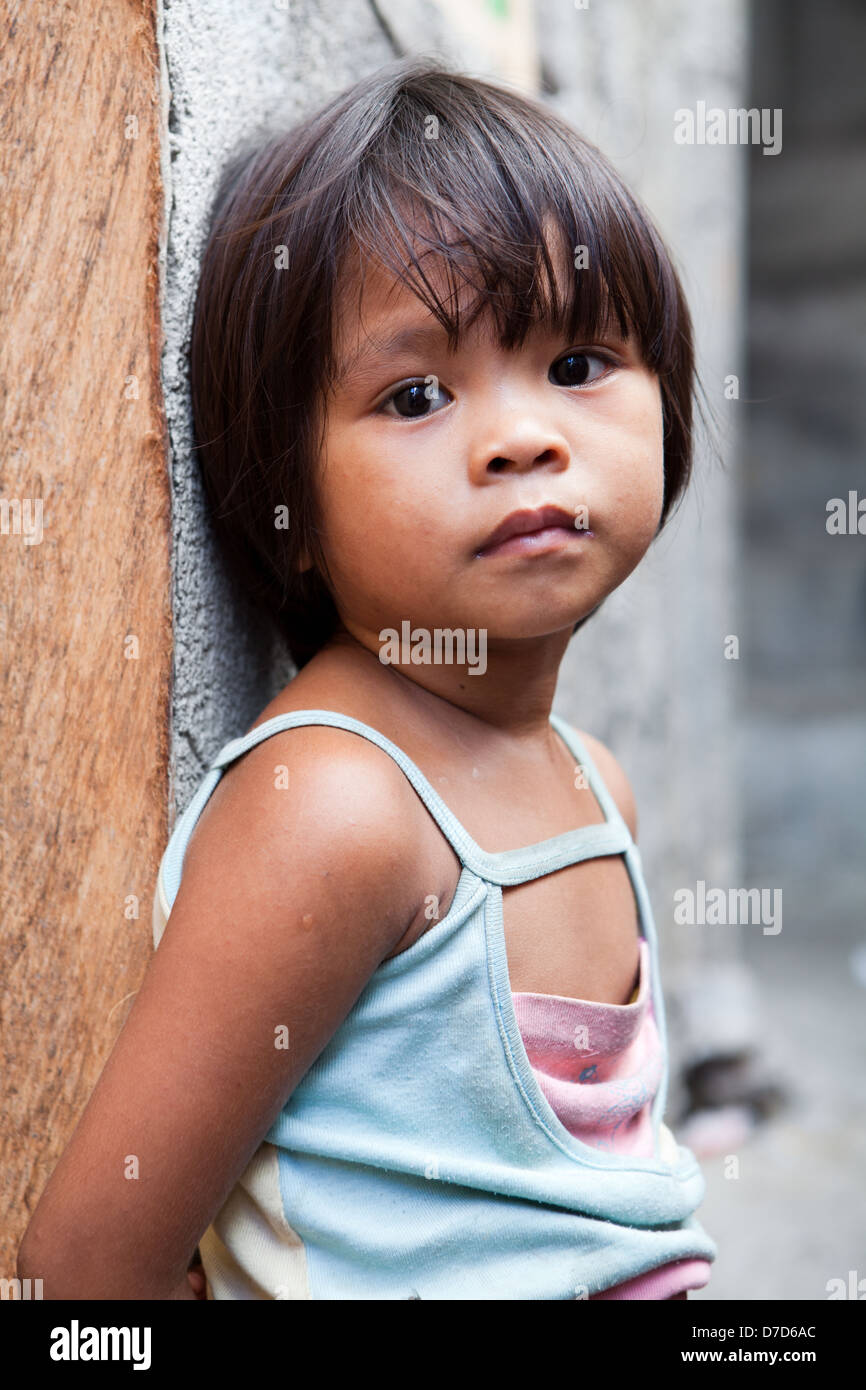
[308,239,663,652]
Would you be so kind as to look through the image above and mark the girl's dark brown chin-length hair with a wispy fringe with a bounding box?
[190,57,695,669]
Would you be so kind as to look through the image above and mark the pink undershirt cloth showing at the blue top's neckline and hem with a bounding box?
[512,937,710,1300]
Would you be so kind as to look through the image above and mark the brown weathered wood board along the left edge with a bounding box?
[0,0,171,1277]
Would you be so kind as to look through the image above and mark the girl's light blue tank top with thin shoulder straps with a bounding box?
[153,709,717,1300]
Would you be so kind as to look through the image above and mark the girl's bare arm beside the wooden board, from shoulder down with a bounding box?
[18,727,421,1298]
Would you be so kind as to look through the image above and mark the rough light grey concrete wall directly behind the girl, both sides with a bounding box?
[163,0,751,1106]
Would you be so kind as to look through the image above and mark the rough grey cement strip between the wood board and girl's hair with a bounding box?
[161,0,393,812]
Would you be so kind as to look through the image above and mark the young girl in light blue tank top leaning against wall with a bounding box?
[21,58,716,1300]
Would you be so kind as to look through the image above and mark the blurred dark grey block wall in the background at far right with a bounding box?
[742,0,866,951]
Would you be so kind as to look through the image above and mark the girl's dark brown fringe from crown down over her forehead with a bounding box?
[329,72,681,384]
